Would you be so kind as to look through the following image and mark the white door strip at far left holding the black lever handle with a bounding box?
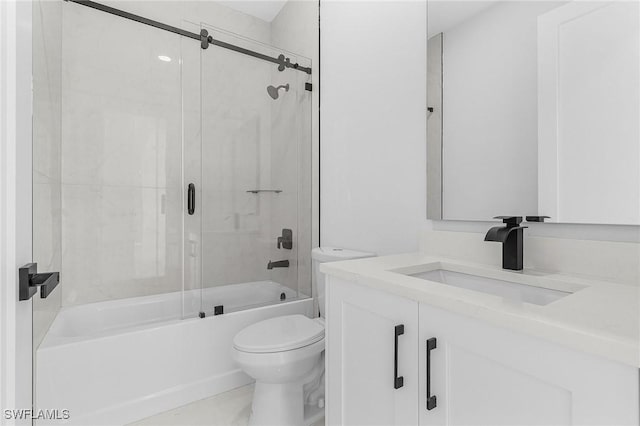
[0,0,32,425]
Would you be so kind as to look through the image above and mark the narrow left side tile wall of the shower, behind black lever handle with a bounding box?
[32,1,62,349]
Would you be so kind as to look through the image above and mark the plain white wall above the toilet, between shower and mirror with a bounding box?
[320,1,427,254]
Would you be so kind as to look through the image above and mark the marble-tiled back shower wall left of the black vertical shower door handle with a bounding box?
[62,3,182,305]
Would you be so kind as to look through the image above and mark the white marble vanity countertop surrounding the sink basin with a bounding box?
[320,253,640,368]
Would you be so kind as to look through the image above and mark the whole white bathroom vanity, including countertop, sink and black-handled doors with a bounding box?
[321,241,640,425]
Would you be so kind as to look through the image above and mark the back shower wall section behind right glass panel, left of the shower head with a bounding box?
[201,31,275,288]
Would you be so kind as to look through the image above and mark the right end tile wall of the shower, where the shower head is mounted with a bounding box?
[271,1,318,296]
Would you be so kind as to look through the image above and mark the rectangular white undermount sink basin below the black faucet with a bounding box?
[407,269,573,305]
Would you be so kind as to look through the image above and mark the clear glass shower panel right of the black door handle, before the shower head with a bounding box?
[199,25,311,315]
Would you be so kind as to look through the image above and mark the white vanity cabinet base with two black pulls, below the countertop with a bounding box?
[326,277,640,425]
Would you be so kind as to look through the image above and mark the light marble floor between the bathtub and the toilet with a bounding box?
[130,385,324,426]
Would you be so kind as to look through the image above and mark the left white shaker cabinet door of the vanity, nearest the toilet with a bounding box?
[326,277,418,426]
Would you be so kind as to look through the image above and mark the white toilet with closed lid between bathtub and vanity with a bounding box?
[233,247,374,426]
